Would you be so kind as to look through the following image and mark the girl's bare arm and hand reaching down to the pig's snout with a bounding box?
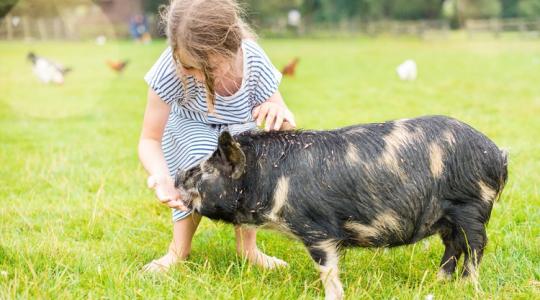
[139,88,186,210]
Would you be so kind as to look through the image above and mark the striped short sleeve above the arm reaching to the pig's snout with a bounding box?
[144,47,184,105]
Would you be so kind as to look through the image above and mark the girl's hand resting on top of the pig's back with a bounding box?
[253,101,296,131]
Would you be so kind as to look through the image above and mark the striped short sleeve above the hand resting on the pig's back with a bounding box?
[249,41,282,106]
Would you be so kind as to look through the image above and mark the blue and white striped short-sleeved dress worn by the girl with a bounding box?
[144,40,281,221]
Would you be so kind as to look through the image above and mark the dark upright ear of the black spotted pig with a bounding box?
[218,131,246,179]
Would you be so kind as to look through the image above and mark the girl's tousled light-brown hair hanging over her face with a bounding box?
[162,0,255,113]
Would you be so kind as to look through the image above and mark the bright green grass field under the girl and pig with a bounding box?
[0,38,540,299]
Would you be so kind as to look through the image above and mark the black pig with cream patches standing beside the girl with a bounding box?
[176,116,508,299]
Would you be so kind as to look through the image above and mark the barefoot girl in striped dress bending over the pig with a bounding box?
[139,0,295,271]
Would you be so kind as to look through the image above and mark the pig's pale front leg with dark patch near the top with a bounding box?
[308,240,343,300]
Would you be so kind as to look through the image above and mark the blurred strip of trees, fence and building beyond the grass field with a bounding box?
[0,0,540,40]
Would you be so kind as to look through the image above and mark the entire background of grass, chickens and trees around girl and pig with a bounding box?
[0,0,540,299]
